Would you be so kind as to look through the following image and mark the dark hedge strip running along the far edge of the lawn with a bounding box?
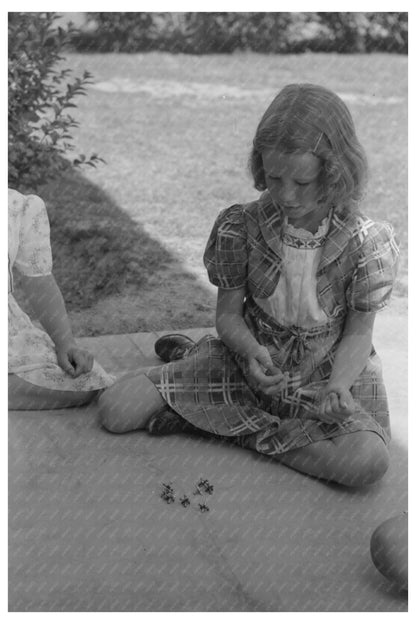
[73,12,408,54]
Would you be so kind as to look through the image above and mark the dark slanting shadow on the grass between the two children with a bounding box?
[12,165,215,336]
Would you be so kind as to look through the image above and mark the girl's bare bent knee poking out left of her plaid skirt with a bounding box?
[98,373,167,433]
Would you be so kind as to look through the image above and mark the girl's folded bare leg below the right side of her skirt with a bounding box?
[249,431,389,487]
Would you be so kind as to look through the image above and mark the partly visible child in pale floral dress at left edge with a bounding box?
[8,189,114,410]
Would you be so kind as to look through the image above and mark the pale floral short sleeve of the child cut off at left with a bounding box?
[14,195,52,277]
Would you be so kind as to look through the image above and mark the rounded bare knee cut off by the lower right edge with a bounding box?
[370,512,408,591]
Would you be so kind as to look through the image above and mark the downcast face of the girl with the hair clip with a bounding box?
[262,149,329,232]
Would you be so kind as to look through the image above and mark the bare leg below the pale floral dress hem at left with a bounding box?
[8,374,100,410]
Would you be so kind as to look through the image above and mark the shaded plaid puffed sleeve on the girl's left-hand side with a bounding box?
[204,205,247,290]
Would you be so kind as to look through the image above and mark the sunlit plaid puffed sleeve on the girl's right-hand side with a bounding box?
[347,222,399,312]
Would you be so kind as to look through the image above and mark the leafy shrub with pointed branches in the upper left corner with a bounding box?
[8,13,102,190]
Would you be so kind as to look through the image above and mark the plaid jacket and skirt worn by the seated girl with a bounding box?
[148,192,398,456]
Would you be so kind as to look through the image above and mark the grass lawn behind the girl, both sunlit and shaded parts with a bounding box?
[30,53,407,335]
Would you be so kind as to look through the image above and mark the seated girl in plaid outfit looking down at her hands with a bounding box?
[99,84,398,486]
